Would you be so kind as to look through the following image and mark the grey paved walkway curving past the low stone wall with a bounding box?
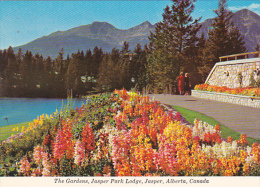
[149,94,260,139]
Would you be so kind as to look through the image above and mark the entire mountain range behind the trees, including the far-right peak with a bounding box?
[14,9,260,58]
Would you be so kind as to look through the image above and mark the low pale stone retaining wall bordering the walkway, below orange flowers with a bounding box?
[191,90,260,109]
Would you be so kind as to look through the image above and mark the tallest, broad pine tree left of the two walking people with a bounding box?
[148,0,201,92]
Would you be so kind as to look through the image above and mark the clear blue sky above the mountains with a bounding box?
[0,0,260,49]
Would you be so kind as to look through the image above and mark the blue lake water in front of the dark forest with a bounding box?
[0,98,86,126]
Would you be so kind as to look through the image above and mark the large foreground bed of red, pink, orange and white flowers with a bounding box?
[0,90,260,176]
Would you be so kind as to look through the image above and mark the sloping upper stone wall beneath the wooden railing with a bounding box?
[205,58,260,88]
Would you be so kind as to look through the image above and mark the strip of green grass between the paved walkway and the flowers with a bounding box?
[172,105,260,146]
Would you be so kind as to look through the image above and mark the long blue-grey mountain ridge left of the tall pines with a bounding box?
[14,21,154,58]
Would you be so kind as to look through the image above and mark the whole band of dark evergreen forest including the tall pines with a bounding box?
[0,0,251,98]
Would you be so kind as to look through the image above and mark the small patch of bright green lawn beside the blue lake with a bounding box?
[0,121,31,142]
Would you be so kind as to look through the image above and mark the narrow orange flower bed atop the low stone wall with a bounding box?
[194,84,260,97]
